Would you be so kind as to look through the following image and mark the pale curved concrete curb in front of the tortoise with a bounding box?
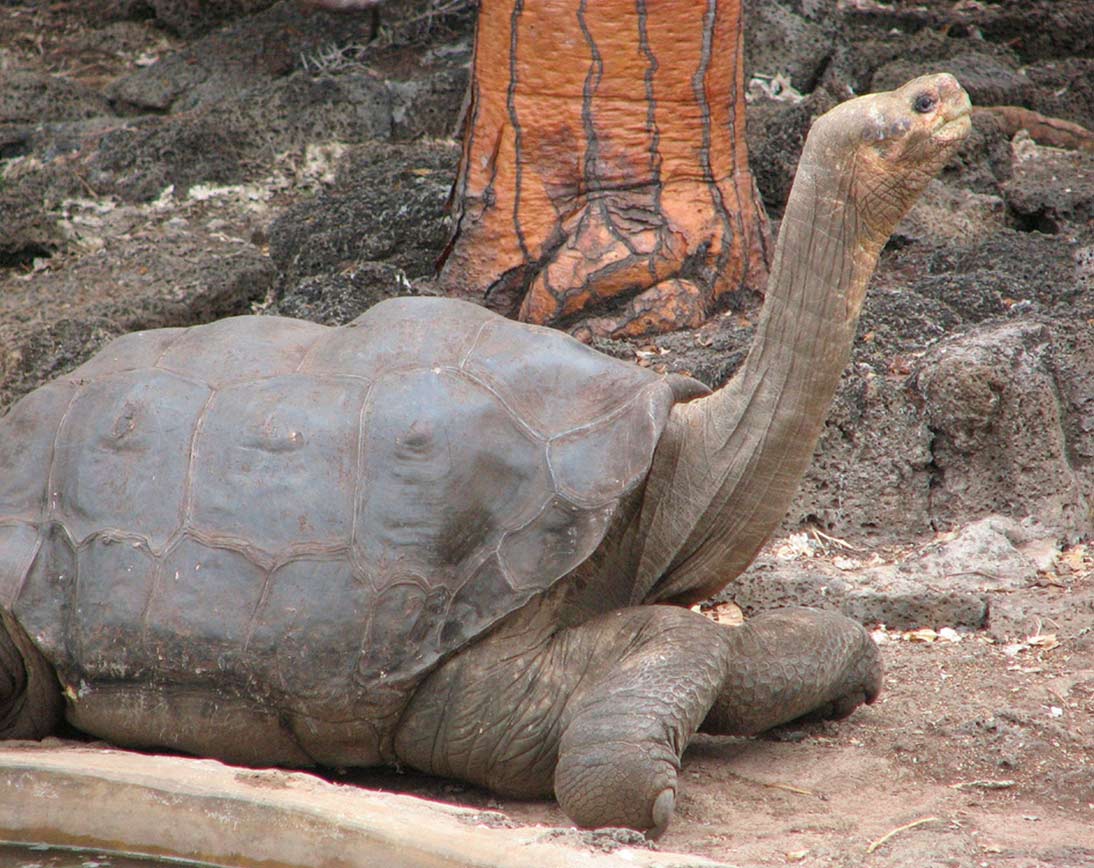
[0,742,735,868]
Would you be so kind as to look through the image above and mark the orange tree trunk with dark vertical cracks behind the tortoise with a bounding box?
[440,0,769,336]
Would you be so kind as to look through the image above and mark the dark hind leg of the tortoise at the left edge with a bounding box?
[0,612,65,739]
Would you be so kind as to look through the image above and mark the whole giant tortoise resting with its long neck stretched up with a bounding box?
[0,74,969,834]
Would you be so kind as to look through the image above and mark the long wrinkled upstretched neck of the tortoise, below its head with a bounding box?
[602,141,892,604]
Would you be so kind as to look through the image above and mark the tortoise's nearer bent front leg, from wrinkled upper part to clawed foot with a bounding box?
[395,605,729,834]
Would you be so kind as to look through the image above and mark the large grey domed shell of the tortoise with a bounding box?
[0,299,673,704]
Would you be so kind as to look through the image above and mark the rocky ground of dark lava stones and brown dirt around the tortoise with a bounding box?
[0,0,1094,868]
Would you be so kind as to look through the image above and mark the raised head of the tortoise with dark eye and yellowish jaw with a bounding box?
[803,72,971,243]
